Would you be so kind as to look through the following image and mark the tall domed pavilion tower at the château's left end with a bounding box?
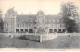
[4,8,16,32]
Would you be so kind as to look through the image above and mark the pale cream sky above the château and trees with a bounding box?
[0,0,80,14]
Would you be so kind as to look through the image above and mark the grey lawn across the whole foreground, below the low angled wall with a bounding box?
[0,36,80,49]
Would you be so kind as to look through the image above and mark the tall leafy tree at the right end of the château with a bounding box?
[61,2,79,32]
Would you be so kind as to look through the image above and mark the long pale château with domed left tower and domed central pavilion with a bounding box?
[4,8,66,33]
